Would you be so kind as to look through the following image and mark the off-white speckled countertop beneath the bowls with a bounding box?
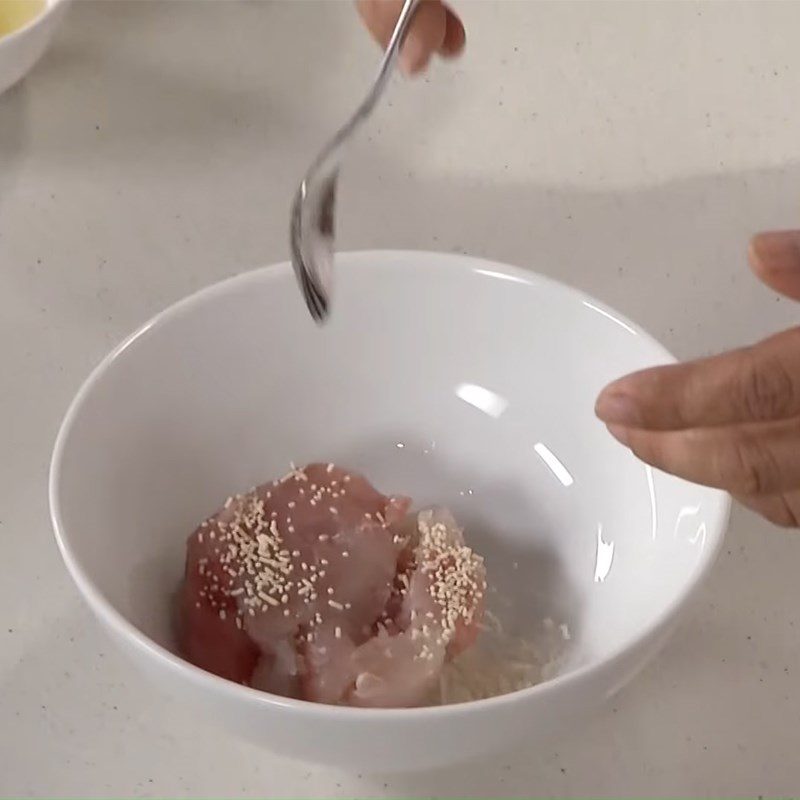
[0,2,800,797]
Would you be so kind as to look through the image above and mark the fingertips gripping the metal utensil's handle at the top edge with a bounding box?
[356,0,467,75]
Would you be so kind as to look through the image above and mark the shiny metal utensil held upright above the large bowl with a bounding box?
[290,0,420,323]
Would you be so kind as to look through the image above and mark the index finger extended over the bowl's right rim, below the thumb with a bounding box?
[596,329,800,430]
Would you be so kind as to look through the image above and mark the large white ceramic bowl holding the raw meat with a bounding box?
[50,252,728,771]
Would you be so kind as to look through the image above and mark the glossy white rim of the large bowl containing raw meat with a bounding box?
[48,253,731,723]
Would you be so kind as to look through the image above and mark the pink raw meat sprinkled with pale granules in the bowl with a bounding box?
[180,464,485,706]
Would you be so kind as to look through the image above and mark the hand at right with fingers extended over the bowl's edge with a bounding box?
[596,231,800,528]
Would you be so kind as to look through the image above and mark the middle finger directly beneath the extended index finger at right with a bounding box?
[609,419,800,497]
